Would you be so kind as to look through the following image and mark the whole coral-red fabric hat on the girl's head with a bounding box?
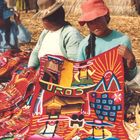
[78,0,109,26]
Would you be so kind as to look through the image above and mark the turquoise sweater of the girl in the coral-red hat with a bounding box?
[77,30,131,61]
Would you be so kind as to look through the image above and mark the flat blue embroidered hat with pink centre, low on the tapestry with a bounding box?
[86,120,113,127]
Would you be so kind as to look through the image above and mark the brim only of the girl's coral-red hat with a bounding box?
[78,7,109,26]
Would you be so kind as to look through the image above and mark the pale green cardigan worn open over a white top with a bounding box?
[28,25,83,68]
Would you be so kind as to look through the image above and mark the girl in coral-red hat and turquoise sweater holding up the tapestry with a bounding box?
[77,0,137,80]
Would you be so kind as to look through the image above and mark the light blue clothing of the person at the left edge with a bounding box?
[0,22,31,52]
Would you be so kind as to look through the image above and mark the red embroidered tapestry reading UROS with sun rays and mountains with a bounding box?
[25,48,128,140]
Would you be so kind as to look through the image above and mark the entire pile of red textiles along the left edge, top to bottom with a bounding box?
[0,50,36,140]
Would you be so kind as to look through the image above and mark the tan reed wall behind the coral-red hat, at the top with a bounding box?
[63,0,136,15]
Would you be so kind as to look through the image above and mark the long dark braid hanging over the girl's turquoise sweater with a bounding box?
[85,33,96,59]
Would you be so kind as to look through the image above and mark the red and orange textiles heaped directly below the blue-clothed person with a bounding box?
[0,50,30,83]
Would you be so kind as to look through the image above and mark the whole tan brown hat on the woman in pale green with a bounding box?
[33,0,64,19]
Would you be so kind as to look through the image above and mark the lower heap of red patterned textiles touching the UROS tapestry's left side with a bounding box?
[0,67,36,139]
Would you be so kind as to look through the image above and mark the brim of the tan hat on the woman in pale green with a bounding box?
[32,2,63,19]
